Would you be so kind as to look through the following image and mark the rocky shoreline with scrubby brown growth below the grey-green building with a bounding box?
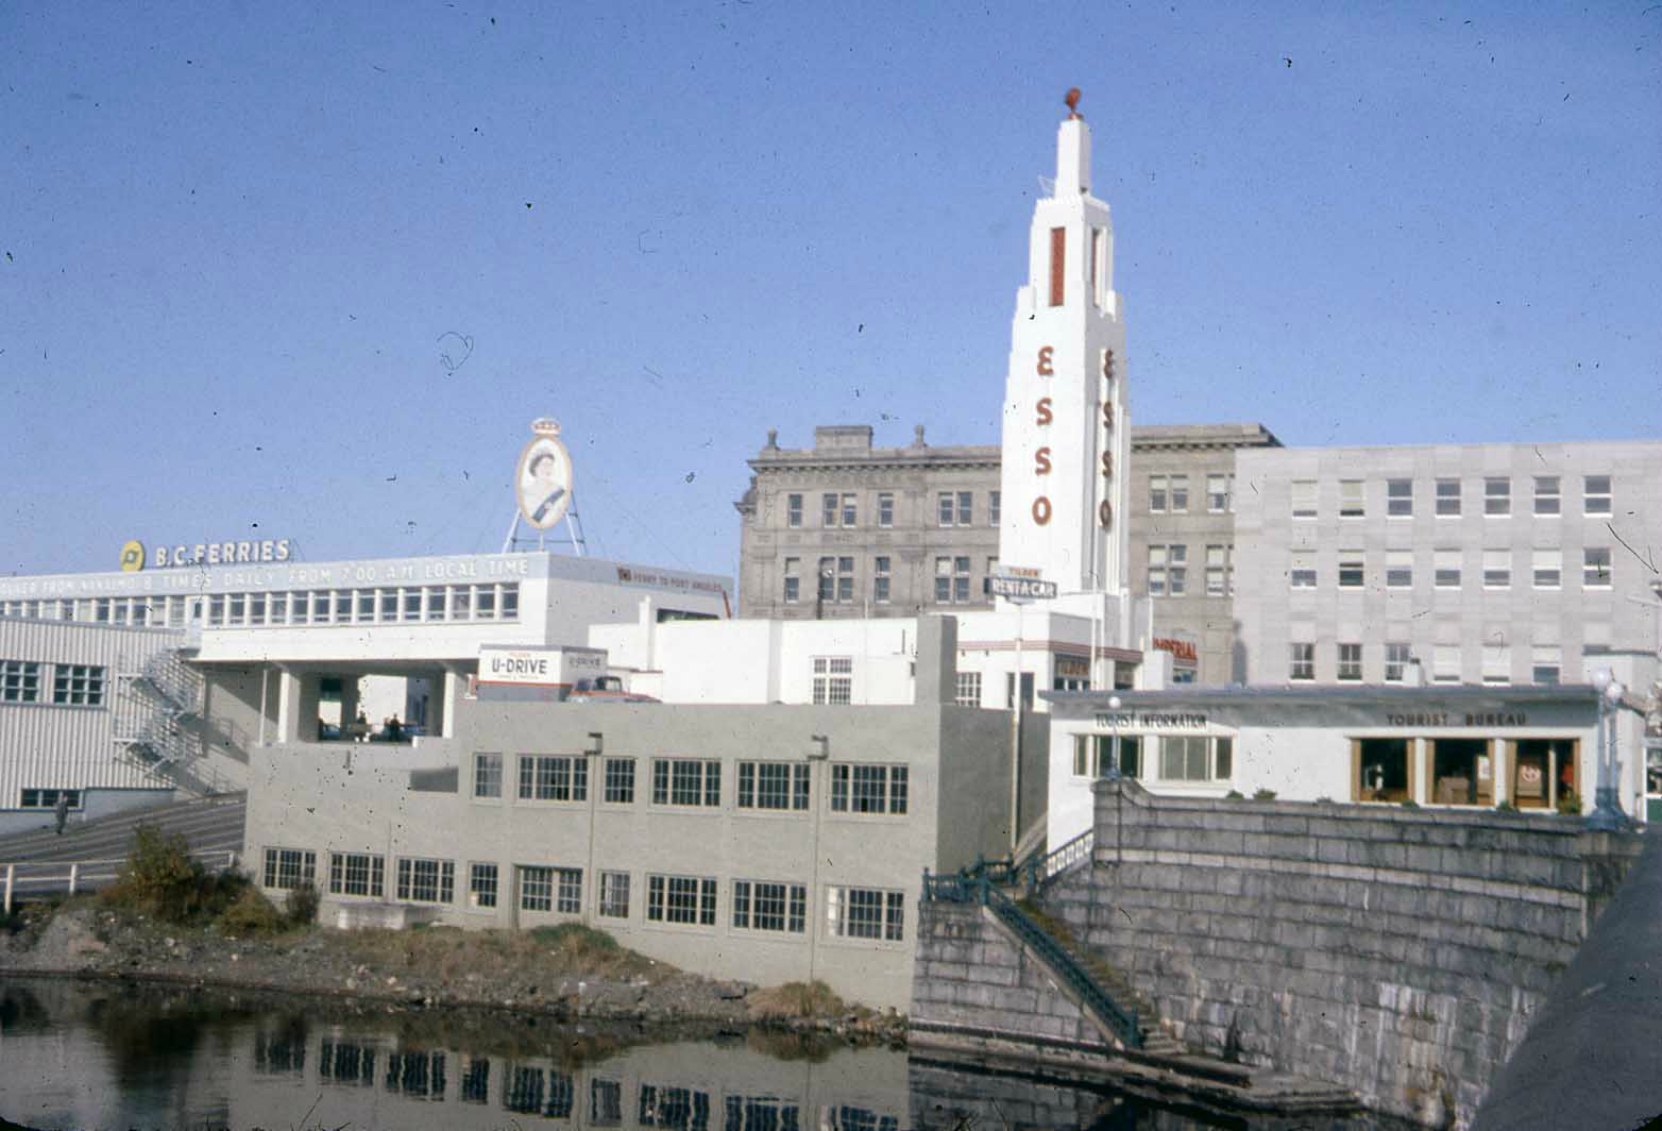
[0,900,906,1046]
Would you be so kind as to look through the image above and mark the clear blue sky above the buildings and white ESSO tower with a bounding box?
[0,0,1662,573]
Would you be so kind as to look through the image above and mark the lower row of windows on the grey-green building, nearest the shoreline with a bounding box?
[280,847,906,942]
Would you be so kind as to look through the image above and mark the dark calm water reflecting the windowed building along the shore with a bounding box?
[0,980,1402,1131]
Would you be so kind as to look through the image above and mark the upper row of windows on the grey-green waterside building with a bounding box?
[474,754,909,815]
